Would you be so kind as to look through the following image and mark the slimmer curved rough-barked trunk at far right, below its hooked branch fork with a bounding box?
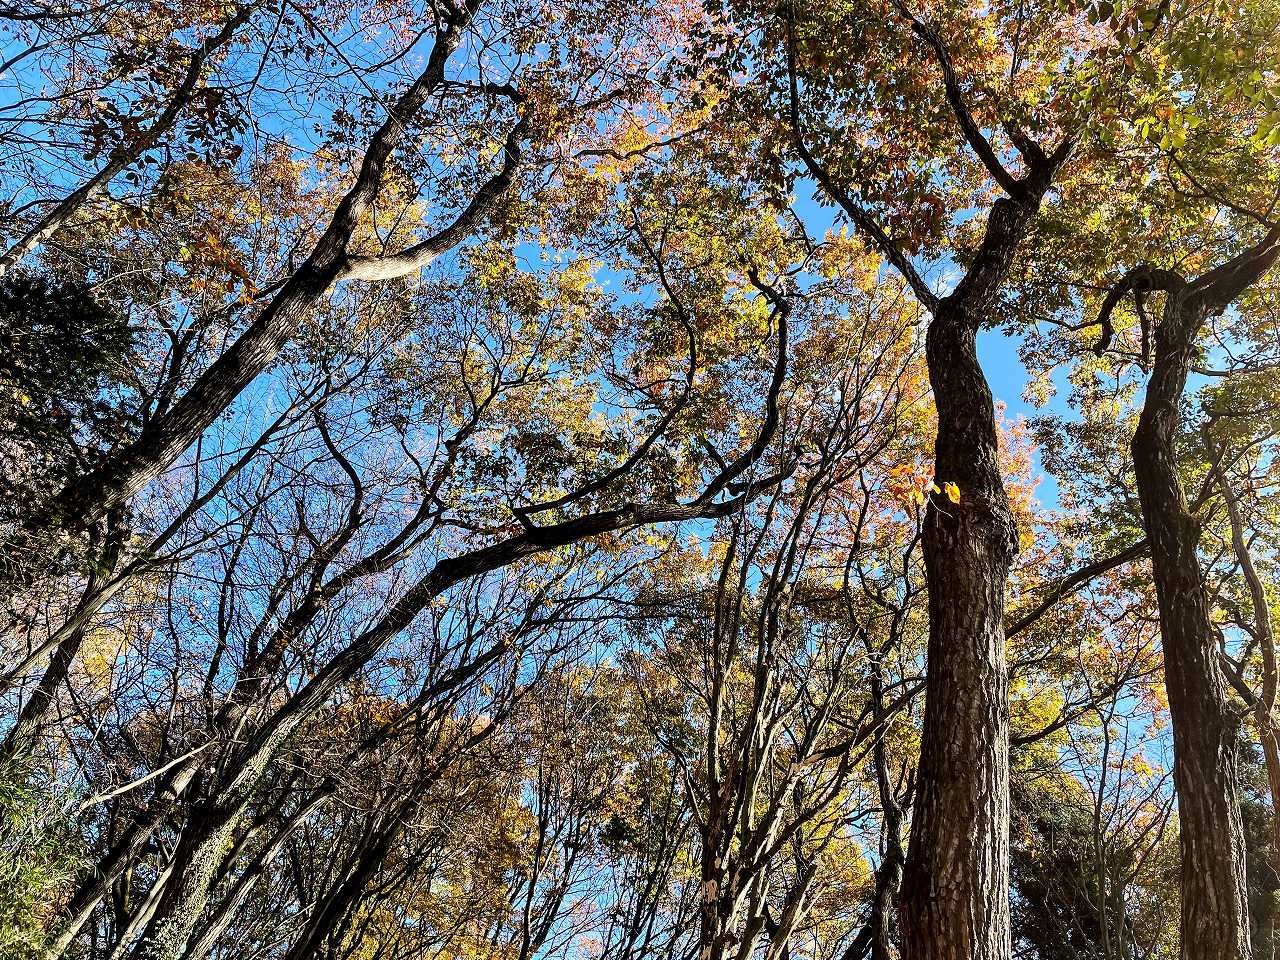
[1133,293,1251,960]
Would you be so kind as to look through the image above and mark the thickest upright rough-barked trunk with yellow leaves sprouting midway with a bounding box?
[901,197,1038,960]
